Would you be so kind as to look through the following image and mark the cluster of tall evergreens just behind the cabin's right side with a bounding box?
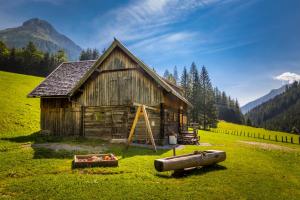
[163,62,244,129]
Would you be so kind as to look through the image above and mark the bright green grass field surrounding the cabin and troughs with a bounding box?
[0,72,300,199]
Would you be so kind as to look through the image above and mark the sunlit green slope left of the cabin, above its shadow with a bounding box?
[0,71,43,136]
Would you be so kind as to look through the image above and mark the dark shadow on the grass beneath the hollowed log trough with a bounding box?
[156,164,227,179]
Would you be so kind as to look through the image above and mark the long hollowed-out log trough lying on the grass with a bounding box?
[154,150,226,172]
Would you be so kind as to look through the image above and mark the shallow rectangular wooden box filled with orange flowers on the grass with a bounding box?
[73,154,118,168]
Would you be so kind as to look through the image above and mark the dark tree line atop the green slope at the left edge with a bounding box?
[0,41,68,76]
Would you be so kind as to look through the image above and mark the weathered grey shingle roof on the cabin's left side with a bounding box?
[28,60,96,97]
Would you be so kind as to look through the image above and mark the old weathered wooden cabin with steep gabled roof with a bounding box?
[28,39,191,144]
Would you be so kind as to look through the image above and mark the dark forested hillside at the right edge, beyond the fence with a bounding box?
[246,82,300,133]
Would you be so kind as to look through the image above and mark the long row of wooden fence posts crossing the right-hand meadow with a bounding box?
[210,129,300,144]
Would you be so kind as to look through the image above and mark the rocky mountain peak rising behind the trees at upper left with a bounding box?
[0,18,81,60]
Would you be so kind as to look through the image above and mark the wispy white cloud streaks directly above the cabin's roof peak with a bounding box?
[91,0,220,47]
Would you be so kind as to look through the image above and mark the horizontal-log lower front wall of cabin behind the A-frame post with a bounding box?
[84,106,160,140]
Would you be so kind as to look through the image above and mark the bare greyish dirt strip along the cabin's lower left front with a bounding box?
[31,143,107,153]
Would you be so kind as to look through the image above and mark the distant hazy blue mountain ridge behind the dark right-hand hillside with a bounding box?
[241,85,286,114]
